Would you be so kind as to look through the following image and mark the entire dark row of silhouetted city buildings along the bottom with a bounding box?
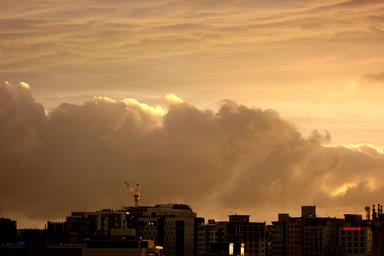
[0,203,384,256]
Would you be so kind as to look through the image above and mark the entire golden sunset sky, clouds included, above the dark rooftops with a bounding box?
[0,0,384,226]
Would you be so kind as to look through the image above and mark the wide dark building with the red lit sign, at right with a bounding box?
[271,206,373,256]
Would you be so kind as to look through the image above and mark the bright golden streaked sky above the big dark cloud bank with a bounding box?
[0,0,384,228]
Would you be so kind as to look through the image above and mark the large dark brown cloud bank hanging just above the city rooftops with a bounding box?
[0,84,384,225]
